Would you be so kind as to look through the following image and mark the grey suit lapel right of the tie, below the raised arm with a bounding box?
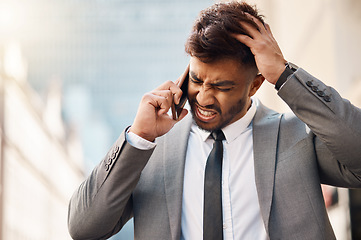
[253,103,282,232]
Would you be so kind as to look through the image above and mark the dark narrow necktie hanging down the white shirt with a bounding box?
[203,130,225,240]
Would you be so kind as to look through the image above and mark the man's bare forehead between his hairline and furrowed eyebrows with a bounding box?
[190,57,253,84]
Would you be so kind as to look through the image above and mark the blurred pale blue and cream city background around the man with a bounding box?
[0,0,361,240]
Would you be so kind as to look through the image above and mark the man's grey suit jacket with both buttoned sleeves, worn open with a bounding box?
[68,69,361,240]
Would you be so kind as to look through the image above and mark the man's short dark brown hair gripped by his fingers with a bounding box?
[185,1,264,67]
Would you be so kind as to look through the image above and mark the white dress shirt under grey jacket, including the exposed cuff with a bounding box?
[127,99,268,240]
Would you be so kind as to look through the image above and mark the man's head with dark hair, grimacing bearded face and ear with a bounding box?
[185,1,264,131]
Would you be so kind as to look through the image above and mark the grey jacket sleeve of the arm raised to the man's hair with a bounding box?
[278,69,361,187]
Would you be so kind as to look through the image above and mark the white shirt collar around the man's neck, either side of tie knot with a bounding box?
[192,99,257,143]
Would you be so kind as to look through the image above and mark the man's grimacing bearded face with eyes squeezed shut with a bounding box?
[188,57,264,131]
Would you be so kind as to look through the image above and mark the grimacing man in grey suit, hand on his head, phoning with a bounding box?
[69,2,361,239]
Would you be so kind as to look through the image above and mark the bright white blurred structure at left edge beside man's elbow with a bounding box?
[0,43,84,240]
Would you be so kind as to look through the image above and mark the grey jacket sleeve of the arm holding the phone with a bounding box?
[68,129,153,240]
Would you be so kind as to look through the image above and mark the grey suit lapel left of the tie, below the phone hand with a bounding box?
[163,114,192,239]
